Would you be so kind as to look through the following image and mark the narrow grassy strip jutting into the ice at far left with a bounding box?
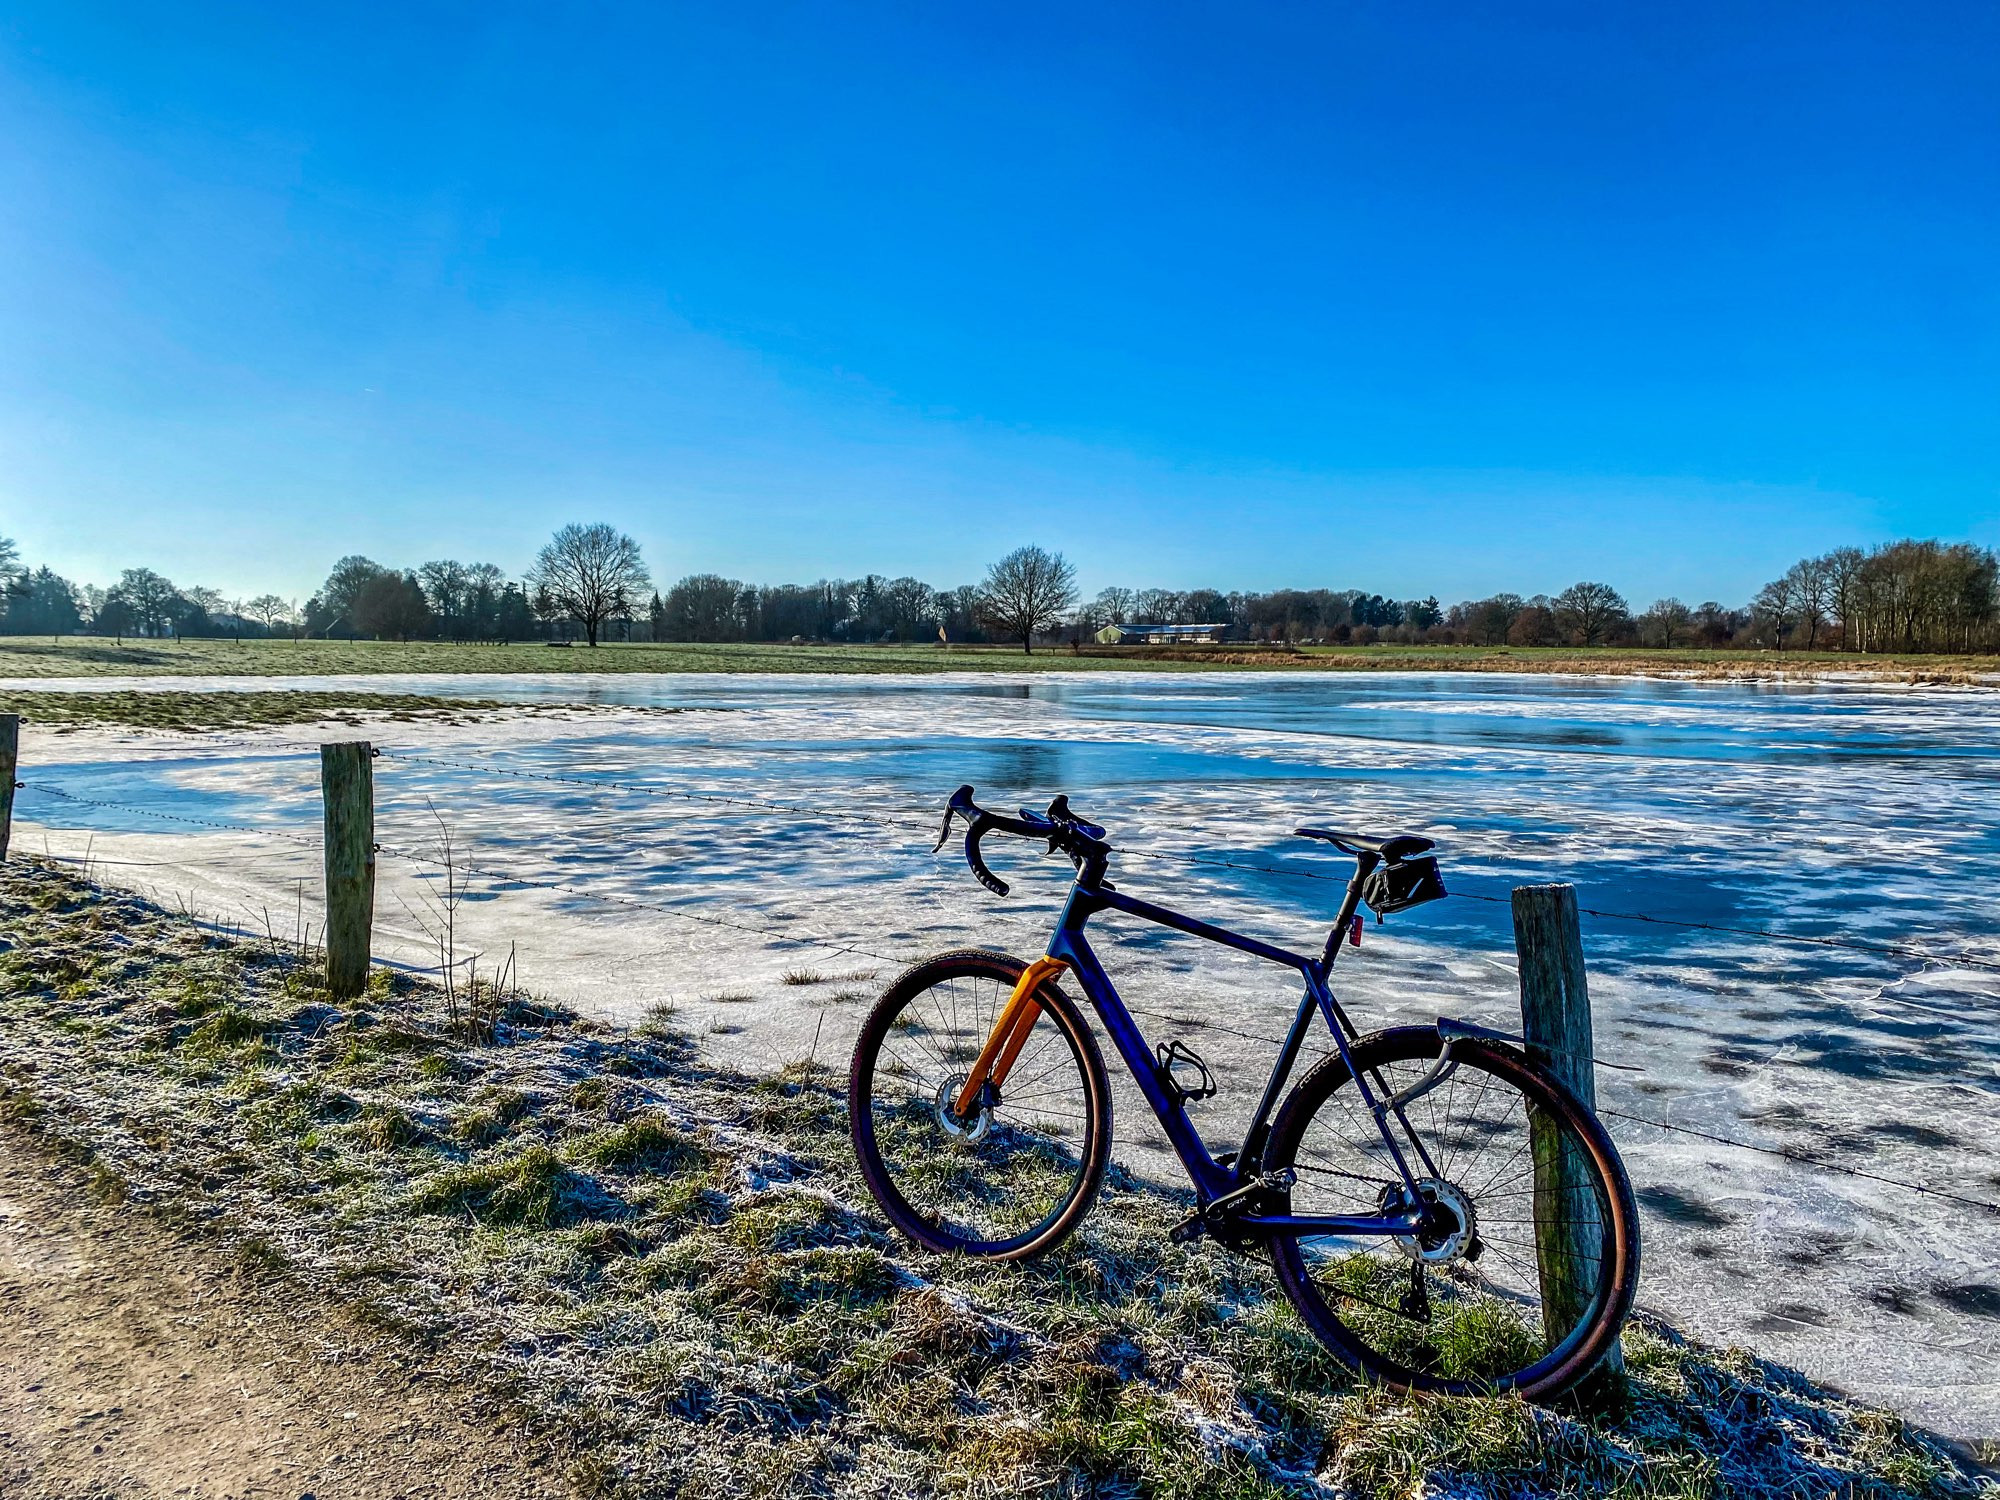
[0,690,678,734]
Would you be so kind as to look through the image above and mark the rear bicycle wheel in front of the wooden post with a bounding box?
[1266,1026,1638,1400]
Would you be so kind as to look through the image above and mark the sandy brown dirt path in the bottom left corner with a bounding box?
[0,1132,568,1500]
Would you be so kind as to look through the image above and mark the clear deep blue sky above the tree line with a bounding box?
[0,0,2000,604]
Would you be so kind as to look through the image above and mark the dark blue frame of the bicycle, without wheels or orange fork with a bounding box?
[1048,854,1442,1238]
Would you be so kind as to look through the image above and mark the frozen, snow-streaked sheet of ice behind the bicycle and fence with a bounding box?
[16,674,2000,1438]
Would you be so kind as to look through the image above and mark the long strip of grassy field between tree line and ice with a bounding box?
[0,638,2000,682]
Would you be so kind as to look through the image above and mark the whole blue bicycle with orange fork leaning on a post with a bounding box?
[848,786,1638,1400]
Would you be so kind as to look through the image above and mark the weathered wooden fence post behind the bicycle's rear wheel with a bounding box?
[1514,886,1624,1374]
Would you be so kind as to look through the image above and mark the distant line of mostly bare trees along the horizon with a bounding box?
[0,524,2000,652]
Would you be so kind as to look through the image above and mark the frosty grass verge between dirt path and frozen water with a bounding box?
[0,864,1992,1496]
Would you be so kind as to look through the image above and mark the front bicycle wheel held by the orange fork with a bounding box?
[848,950,1112,1260]
